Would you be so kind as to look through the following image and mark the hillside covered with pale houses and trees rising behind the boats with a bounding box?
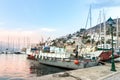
[30,19,120,51]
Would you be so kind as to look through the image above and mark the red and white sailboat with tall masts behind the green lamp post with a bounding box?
[81,9,119,61]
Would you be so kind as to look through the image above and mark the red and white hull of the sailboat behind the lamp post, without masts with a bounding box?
[80,47,120,61]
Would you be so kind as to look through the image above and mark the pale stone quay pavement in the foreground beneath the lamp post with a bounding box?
[29,63,120,80]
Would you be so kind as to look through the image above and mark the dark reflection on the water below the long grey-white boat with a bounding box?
[29,61,66,76]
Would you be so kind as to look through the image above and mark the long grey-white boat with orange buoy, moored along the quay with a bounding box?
[36,48,98,69]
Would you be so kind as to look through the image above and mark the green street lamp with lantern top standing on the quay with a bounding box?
[107,17,116,71]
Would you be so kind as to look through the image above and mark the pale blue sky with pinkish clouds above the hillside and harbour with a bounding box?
[0,0,120,47]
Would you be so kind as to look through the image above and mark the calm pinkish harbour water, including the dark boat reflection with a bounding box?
[0,54,66,80]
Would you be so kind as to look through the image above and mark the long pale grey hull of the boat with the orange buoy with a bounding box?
[38,59,98,69]
